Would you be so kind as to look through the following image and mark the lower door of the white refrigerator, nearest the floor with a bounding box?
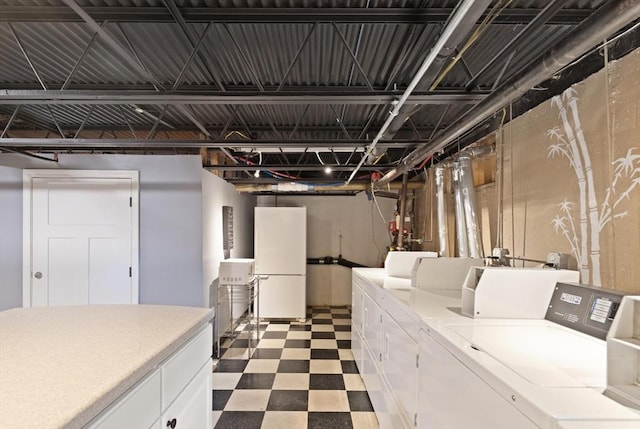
[258,275,307,319]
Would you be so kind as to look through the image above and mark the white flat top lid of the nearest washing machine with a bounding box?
[447,321,607,389]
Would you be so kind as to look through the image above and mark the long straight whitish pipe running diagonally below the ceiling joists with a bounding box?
[346,0,489,185]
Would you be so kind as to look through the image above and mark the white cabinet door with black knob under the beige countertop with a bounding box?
[161,361,213,429]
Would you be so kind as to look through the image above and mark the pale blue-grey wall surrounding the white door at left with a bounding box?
[0,154,208,310]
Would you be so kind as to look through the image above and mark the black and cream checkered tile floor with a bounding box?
[213,307,378,429]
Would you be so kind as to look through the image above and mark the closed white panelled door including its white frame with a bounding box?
[23,170,138,307]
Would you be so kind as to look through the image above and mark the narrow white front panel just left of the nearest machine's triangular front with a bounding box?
[382,312,419,427]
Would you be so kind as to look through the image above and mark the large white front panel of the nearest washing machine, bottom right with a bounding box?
[418,331,536,429]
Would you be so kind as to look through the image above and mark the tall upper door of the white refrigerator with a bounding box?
[255,207,307,275]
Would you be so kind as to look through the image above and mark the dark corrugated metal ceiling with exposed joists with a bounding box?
[0,0,632,182]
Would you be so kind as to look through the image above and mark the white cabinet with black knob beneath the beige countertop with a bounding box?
[86,324,213,429]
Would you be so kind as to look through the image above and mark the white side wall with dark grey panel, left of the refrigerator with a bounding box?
[202,170,256,336]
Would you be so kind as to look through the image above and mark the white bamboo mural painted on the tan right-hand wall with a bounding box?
[546,88,640,286]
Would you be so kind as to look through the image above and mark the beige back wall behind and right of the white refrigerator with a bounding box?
[258,193,396,305]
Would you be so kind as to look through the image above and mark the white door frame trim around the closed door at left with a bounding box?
[22,169,140,307]
